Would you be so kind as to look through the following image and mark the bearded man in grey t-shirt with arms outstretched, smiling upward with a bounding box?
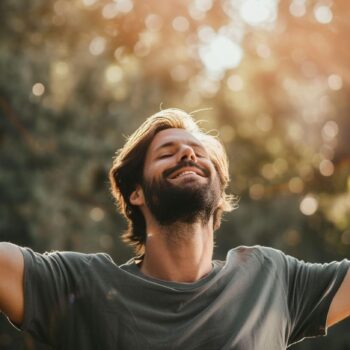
[0,109,350,350]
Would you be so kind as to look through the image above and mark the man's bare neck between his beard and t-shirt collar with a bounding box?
[141,218,214,282]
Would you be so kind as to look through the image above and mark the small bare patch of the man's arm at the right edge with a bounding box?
[327,269,350,327]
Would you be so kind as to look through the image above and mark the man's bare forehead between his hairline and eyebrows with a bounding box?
[148,128,205,152]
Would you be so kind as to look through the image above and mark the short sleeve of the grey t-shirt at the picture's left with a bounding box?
[20,248,90,345]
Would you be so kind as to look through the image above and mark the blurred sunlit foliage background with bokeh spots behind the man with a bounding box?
[0,0,350,350]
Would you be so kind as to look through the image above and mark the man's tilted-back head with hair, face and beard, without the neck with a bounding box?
[109,108,234,253]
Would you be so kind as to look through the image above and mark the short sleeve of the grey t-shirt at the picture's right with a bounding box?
[265,248,350,345]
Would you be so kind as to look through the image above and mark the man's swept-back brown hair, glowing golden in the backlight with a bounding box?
[109,108,236,254]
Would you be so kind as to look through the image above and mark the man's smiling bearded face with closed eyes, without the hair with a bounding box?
[142,129,220,225]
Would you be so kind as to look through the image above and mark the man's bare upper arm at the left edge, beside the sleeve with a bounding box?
[0,242,24,325]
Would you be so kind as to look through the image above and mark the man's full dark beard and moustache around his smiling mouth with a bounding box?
[142,162,220,226]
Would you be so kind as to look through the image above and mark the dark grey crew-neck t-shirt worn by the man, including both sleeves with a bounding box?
[21,246,350,350]
